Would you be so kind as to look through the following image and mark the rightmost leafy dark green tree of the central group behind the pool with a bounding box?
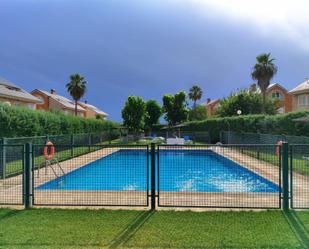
[163,91,189,126]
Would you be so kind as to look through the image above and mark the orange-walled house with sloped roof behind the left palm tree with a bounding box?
[31,89,86,117]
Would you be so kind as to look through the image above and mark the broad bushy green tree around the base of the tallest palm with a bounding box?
[216,89,278,117]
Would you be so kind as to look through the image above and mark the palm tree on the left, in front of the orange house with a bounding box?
[66,74,87,116]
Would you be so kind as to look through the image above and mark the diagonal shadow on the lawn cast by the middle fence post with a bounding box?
[109,210,155,248]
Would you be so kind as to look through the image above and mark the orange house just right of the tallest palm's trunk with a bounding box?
[266,83,293,114]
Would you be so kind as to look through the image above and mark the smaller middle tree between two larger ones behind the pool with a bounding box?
[145,99,162,131]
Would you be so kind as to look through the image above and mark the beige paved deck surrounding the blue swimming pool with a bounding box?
[0,146,309,210]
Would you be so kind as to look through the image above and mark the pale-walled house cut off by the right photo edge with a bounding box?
[290,79,309,111]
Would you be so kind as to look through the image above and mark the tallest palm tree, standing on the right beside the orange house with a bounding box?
[251,53,277,113]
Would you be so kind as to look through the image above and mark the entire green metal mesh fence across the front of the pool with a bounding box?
[0,141,309,210]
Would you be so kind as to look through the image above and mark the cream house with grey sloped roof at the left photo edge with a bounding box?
[0,78,40,109]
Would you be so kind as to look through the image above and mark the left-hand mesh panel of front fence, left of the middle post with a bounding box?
[32,145,149,206]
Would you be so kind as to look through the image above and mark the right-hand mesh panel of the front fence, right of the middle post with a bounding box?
[157,145,281,209]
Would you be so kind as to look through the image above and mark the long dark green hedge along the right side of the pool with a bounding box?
[183,111,309,142]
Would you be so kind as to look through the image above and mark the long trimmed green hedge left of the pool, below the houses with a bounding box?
[0,104,116,137]
